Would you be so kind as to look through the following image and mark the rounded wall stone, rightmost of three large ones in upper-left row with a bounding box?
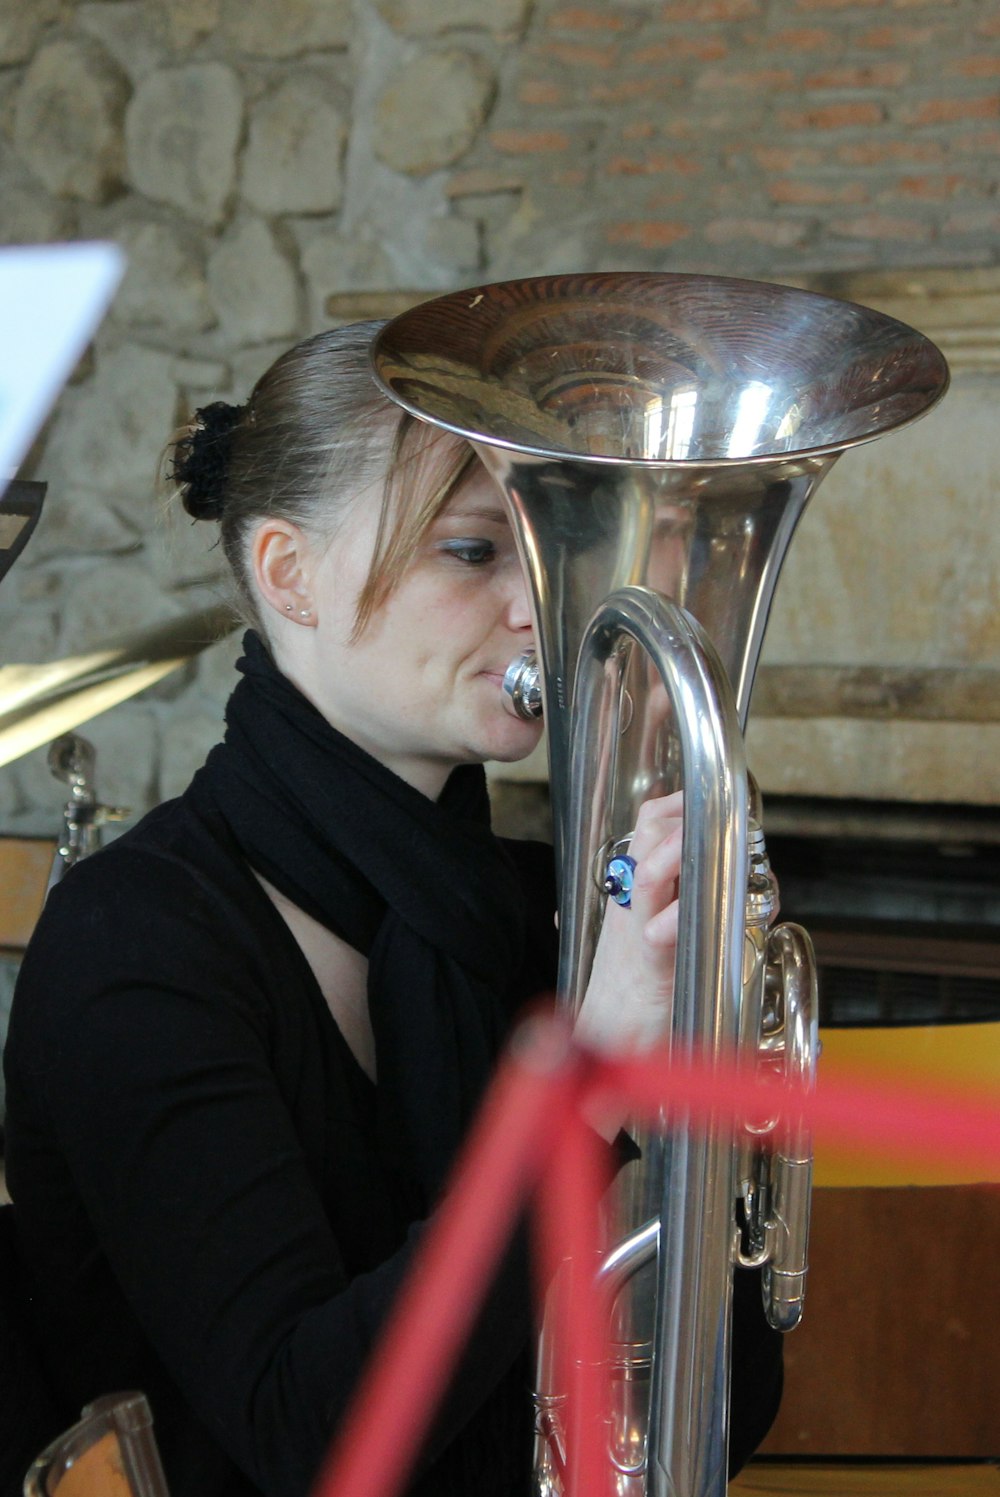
[241,73,347,214]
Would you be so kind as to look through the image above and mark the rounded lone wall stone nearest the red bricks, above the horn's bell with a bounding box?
[373,51,496,177]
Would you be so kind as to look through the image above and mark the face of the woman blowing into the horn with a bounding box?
[296,466,542,796]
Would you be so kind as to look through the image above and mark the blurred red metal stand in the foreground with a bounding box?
[313,1016,1000,1497]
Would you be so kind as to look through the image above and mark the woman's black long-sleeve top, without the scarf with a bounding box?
[6,780,780,1497]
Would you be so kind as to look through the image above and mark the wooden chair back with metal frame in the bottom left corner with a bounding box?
[24,1392,168,1497]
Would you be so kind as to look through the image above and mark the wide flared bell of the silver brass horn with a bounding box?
[373,272,948,886]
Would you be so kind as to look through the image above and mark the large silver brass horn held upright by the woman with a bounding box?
[373,274,948,1497]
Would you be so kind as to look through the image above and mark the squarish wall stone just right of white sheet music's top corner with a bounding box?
[111,223,216,334]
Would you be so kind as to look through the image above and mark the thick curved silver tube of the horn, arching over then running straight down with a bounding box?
[560,587,749,1494]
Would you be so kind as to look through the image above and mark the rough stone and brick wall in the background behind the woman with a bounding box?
[0,0,1000,832]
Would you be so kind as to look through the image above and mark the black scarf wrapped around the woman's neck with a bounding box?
[197,633,535,1219]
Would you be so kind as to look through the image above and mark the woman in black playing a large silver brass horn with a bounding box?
[6,325,780,1497]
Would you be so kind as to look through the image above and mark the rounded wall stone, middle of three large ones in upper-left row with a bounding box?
[126,63,243,225]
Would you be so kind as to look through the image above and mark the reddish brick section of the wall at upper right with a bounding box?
[448,0,1000,274]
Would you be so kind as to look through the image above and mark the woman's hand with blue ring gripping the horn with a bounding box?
[575,792,683,1052]
